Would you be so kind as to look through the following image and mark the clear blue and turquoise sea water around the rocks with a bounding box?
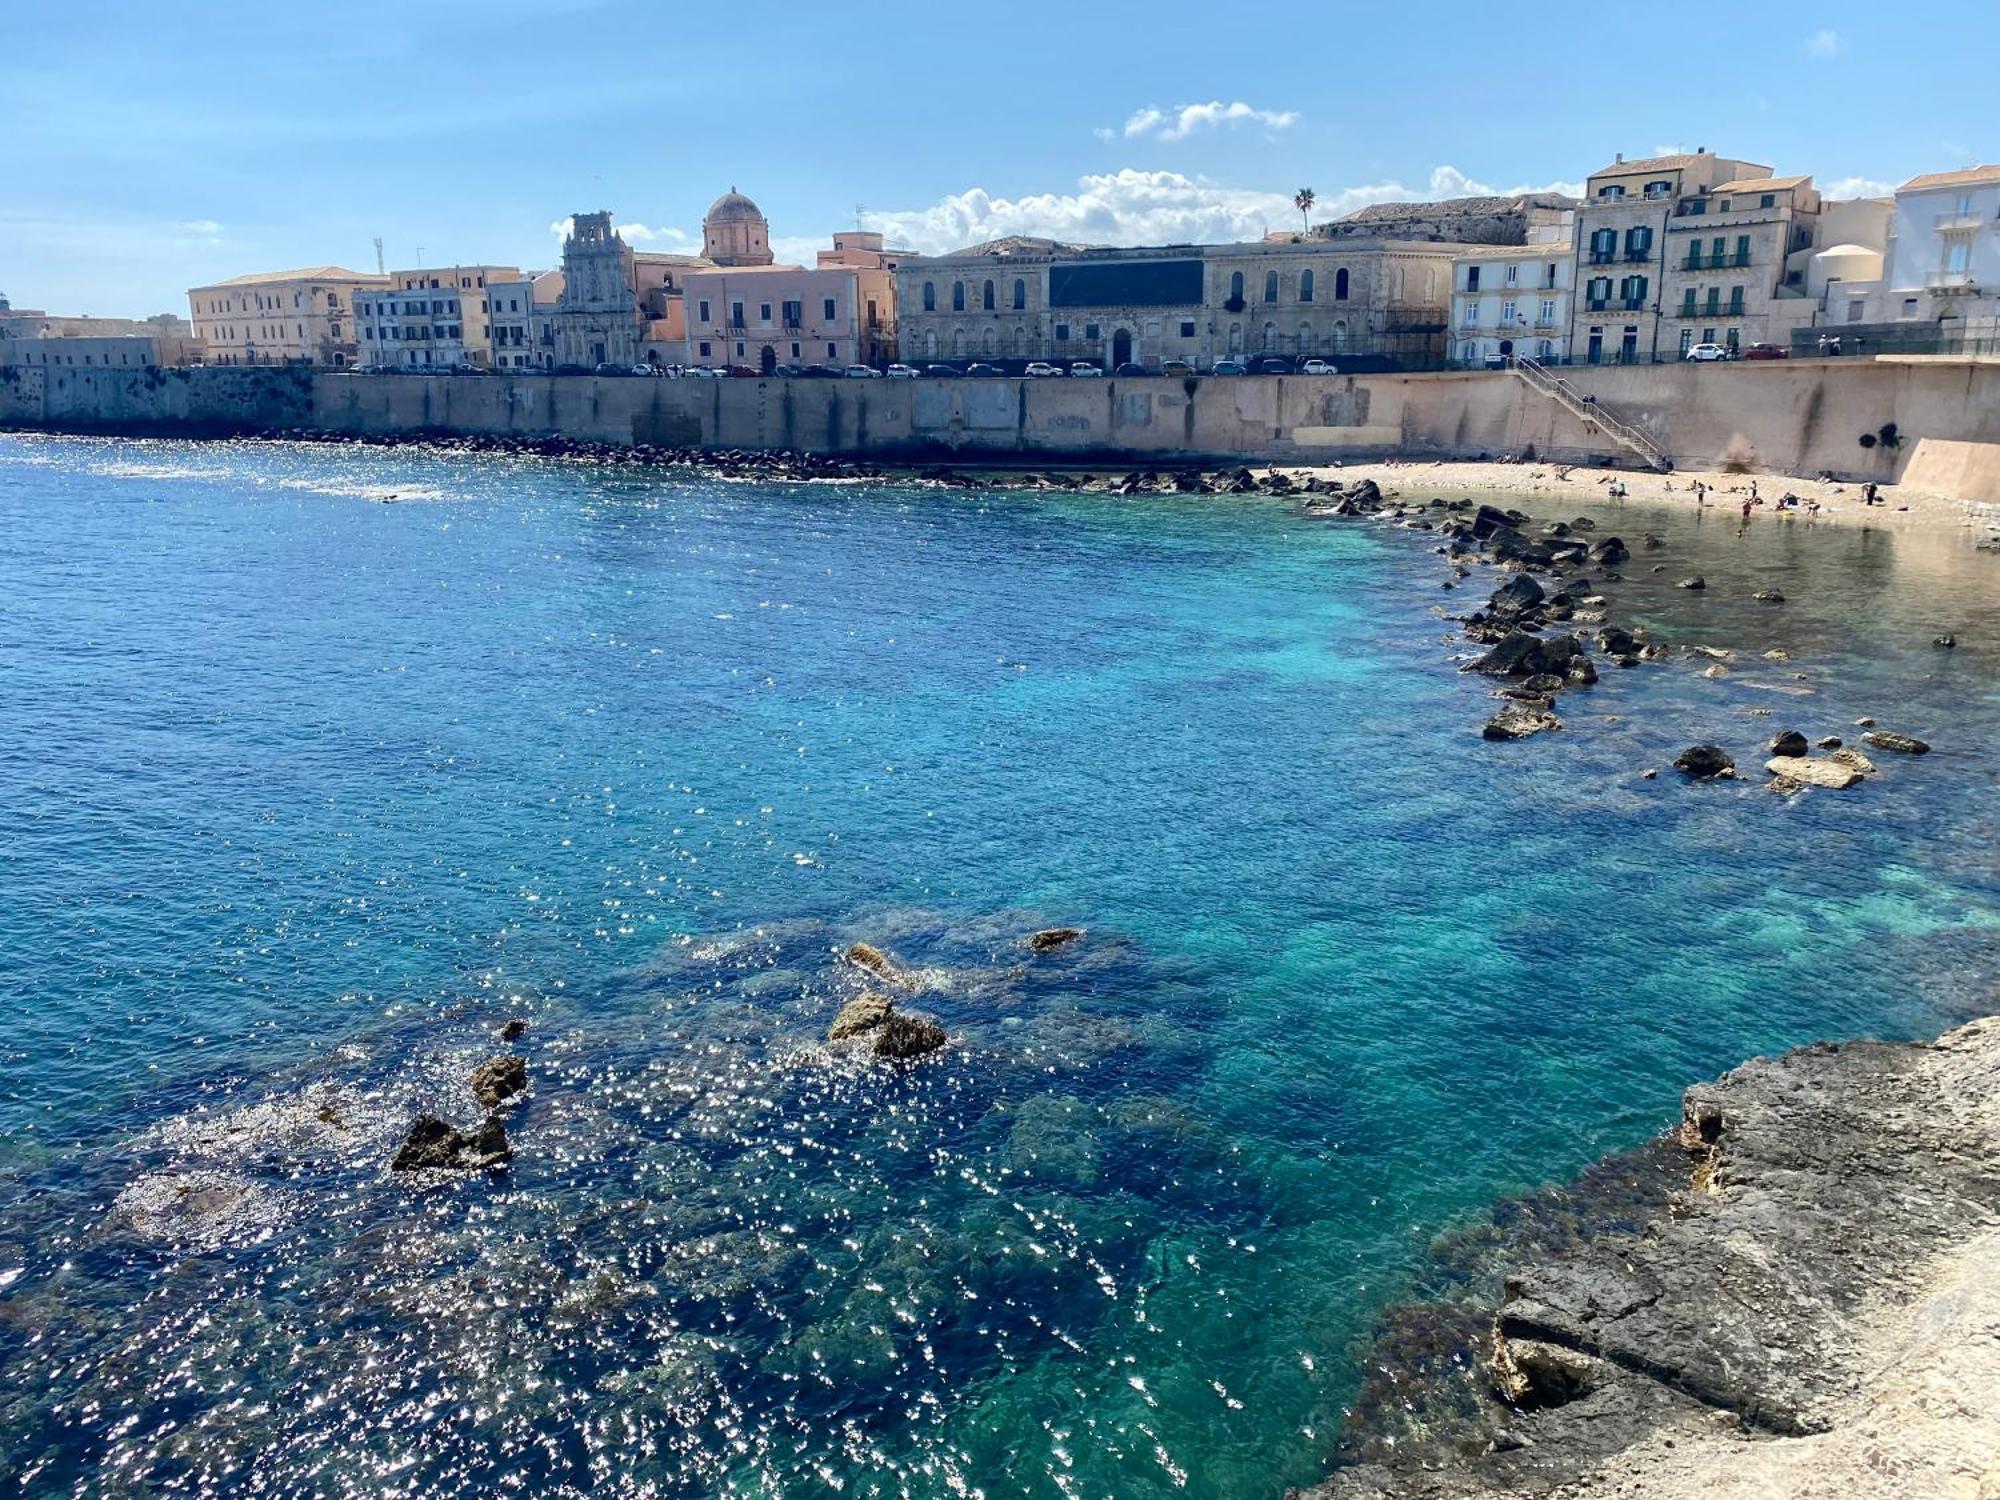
[0,438,2000,1498]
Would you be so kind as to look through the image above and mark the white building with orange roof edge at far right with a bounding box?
[1880,166,2000,334]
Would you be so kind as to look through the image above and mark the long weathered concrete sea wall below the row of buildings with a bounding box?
[11,360,2000,484]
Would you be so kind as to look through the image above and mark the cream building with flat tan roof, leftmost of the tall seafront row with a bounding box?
[188,266,390,368]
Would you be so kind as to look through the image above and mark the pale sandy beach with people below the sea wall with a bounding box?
[1280,458,2000,538]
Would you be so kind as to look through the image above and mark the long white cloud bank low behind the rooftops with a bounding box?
[868,166,1582,254]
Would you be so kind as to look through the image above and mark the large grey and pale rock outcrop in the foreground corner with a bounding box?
[1302,1016,2000,1500]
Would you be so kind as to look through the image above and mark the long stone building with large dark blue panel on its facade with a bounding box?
[896,236,1468,370]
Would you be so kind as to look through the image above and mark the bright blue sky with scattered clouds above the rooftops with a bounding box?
[0,0,2000,316]
